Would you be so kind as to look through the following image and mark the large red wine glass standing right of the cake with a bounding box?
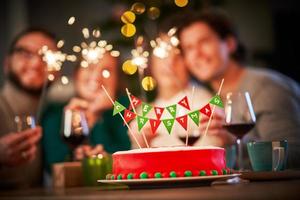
[223,92,256,171]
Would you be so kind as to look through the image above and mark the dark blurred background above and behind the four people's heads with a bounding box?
[0,0,300,83]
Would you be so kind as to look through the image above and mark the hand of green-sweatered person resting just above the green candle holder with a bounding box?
[74,144,107,160]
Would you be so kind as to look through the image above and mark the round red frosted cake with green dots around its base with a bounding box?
[107,147,230,179]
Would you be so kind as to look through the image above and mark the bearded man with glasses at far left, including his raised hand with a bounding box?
[0,28,57,189]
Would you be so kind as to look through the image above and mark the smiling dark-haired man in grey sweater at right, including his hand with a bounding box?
[178,9,300,167]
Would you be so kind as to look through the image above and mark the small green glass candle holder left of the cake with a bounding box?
[82,154,112,186]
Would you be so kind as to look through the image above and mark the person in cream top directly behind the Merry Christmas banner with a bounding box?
[131,27,214,148]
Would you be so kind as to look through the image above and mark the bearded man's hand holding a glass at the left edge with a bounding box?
[0,127,42,166]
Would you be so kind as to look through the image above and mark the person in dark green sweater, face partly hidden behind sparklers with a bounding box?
[42,53,131,173]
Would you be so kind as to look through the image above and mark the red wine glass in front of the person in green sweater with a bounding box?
[62,109,89,158]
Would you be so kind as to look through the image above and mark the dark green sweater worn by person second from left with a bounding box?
[42,97,131,172]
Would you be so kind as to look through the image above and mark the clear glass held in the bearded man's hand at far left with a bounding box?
[14,115,36,132]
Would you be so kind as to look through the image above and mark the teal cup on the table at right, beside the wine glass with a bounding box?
[247,140,288,171]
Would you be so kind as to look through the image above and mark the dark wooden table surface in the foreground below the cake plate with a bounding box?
[0,179,300,200]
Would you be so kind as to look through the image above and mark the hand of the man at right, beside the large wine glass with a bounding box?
[200,108,236,147]
